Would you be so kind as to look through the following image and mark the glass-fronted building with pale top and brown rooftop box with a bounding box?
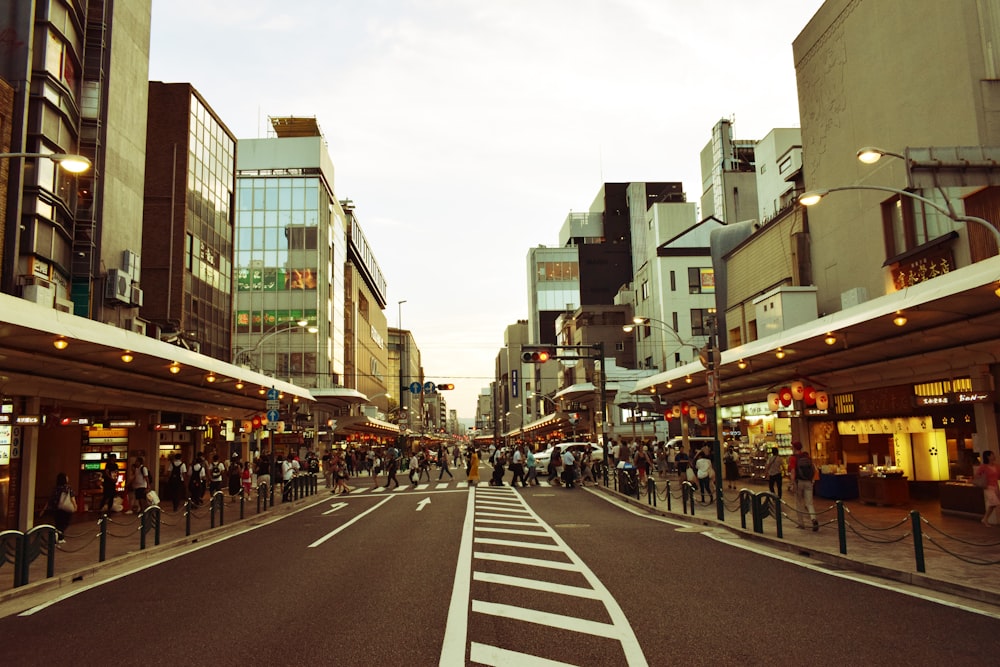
[233,118,347,387]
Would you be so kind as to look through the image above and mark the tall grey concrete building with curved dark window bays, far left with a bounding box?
[0,0,151,320]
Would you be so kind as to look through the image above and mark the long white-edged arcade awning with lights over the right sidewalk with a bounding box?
[635,257,1000,405]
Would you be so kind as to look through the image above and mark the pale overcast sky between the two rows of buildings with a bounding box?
[149,0,823,421]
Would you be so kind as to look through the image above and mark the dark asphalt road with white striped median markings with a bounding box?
[0,476,1000,667]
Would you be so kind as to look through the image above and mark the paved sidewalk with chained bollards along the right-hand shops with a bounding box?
[599,480,1000,606]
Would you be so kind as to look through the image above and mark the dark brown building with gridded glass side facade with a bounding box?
[142,81,236,361]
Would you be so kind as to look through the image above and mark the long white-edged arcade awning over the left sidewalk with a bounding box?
[0,294,313,419]
